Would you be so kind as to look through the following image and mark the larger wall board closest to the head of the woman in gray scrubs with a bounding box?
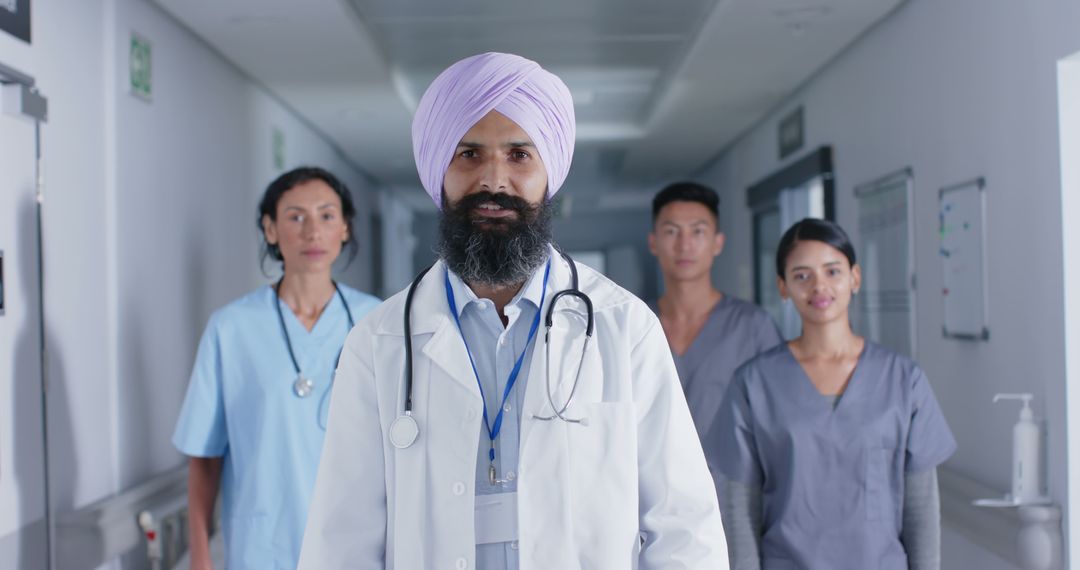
[854,168,916,358]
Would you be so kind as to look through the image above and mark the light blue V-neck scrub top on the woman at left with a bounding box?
[173,285,379,570]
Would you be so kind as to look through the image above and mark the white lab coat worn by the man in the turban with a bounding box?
[299,254,728,570]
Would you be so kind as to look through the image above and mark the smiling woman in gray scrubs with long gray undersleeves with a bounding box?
[710,218,956,570]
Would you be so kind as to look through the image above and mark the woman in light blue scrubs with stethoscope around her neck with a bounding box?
[173,167,379,570]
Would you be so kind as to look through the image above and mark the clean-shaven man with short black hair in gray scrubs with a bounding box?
[649,182,783,490]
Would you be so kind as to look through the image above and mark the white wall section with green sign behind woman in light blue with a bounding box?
[113,0,380,487]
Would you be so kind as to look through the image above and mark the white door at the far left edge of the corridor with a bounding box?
[0,73,49,569]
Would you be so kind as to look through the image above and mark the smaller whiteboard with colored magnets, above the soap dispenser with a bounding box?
[937,178,990,340]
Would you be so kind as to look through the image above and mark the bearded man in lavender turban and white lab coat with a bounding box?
[300,53,727,570]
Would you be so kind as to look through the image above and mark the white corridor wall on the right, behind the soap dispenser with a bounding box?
[702,0,1080,568]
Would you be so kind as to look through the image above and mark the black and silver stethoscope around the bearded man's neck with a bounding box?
[390,252,593,449]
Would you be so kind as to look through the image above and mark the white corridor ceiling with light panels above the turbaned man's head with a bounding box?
[147,0,903,202]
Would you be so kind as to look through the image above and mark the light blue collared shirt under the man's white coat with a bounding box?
[449,261,546,570]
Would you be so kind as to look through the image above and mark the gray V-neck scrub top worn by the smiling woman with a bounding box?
[710,341,956,570]
